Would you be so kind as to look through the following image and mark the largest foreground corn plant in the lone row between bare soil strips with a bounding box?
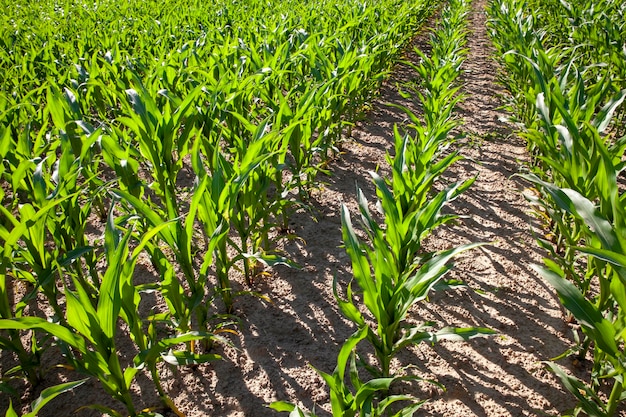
[335,179,493,378]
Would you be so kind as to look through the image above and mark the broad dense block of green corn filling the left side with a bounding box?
[0,0,435,416]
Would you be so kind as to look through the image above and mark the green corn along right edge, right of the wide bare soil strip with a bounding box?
[490,0,626,417]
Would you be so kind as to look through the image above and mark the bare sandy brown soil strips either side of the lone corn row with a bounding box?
[28,0,580,417]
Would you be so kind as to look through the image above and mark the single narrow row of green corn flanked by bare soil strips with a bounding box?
[272,0,492,417]
